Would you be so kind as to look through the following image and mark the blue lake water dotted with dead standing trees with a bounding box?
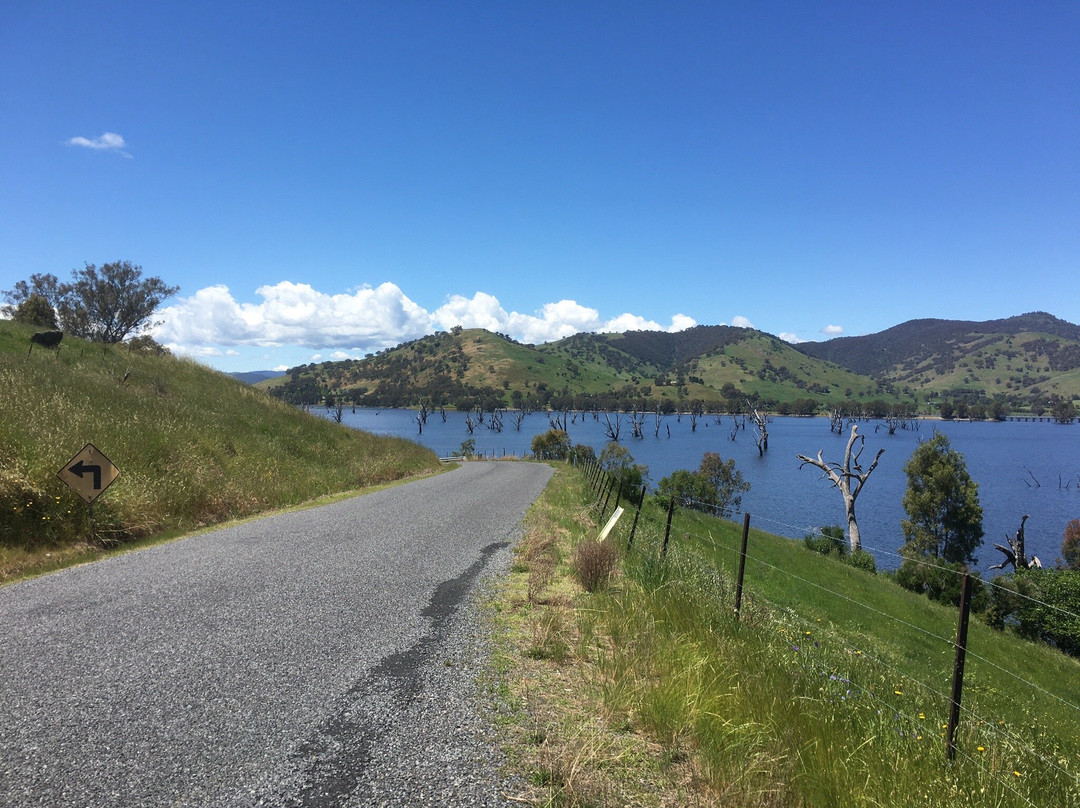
[314,408,1080,575]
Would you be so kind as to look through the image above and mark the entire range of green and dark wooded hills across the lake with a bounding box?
[259,312,1080,413]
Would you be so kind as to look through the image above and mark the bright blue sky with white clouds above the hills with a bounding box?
[0,0,1080,371]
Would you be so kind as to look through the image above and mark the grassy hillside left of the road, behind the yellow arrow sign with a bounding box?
[0,321,438,582]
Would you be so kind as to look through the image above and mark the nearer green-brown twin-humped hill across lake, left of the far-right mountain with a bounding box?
[266,326,901,414]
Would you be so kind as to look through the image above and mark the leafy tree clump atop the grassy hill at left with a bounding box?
[3,261,179,344]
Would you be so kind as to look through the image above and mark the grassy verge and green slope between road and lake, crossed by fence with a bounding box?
[496,468,1080,808]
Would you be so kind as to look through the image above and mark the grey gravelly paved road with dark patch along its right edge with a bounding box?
[0,462,551,807]
